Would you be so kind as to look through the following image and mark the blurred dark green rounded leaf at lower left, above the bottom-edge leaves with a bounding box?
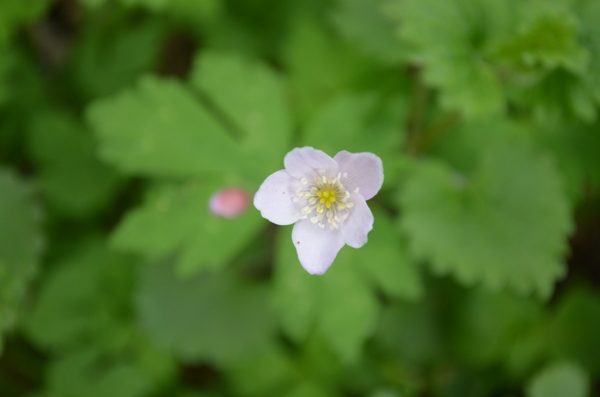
[27,241,133,351]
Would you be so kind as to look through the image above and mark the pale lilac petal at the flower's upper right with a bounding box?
[334,150,383,200]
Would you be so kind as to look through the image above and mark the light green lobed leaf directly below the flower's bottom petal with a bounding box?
[273,224,379,362]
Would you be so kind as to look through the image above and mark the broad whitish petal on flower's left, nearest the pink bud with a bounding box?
[254,170,306,225]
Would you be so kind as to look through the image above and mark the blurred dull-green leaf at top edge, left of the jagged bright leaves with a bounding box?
[333,0,407,65]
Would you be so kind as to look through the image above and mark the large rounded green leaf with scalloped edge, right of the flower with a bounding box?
[400,131,572,298]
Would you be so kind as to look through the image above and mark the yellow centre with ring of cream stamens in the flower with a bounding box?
[296,170,352,230]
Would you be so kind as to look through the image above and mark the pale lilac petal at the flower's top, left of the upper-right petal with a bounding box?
[283,146,338,179]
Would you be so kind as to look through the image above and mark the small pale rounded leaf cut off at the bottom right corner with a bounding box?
[527,363,590,397]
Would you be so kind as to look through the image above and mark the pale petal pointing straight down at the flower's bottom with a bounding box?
[292,219,344,274]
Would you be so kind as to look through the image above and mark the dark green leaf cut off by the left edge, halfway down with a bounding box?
[0,169,43,347]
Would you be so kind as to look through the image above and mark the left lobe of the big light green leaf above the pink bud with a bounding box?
[87,76,238,177]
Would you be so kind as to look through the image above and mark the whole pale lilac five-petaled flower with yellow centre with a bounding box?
[254,147,383,274]
